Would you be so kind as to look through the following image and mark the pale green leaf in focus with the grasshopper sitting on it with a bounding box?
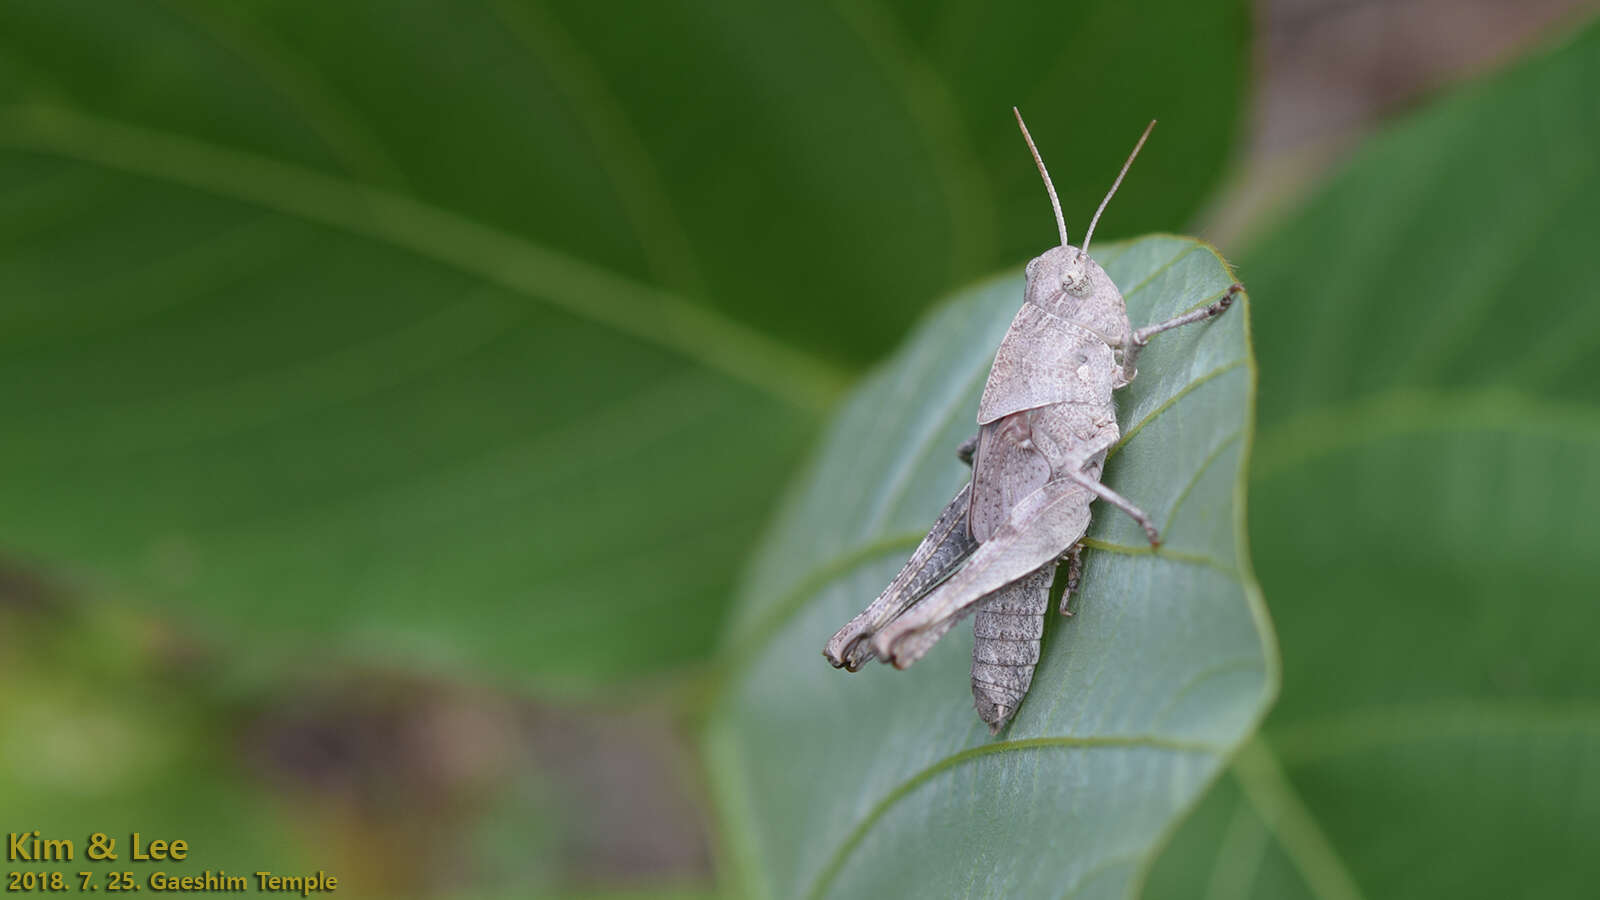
[707,237,1277,897]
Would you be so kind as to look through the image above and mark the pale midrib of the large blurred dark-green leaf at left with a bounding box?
[0,104,853,412]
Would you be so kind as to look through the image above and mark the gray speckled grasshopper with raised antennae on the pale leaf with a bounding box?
[822,109,1243,733]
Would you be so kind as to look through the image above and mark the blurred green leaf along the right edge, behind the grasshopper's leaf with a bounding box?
[1150,15,1600,900]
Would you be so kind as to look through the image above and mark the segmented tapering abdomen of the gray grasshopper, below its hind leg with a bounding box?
[973,560,1056,735]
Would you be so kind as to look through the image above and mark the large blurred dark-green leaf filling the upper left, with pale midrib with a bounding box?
[0,0,1246,687]
